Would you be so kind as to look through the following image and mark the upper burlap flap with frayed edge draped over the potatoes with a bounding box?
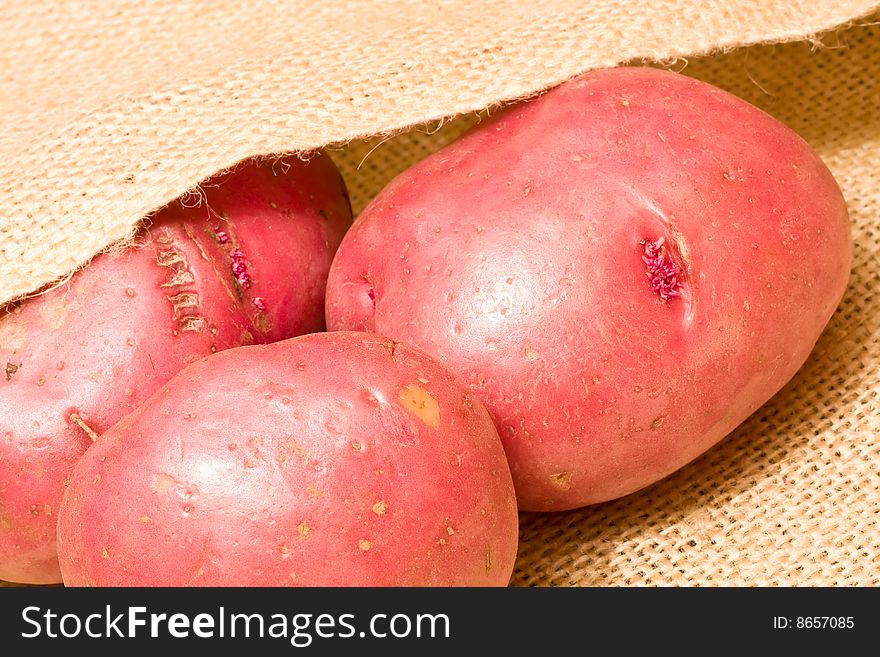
[0,0,876,301]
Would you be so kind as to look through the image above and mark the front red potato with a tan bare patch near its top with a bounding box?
[58,332,518,586]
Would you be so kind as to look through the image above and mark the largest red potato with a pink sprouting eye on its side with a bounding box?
[327,67,851,511]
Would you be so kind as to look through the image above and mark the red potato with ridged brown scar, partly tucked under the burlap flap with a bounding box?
[0,154,351,584]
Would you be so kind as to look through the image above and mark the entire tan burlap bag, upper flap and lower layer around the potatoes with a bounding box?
[0,0,880,586]
